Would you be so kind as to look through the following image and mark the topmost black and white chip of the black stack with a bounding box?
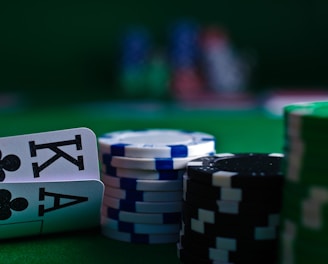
[187,153,283,188]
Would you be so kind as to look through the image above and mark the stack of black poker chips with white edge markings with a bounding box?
[177,153,283,264]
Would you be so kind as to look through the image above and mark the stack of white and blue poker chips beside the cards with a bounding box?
[98,129,215,244]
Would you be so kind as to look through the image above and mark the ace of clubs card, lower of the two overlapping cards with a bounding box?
[0,180,104,239]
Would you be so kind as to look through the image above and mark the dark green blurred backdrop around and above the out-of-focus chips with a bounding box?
[0,0,328,104]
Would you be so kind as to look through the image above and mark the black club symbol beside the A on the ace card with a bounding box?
[0,189,28,220]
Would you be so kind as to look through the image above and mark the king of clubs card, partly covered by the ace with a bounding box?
[0,128,100,183]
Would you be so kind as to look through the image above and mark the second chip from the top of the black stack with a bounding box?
[183,176,282,202]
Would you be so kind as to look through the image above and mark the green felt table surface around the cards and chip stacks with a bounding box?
[0,103,283,264]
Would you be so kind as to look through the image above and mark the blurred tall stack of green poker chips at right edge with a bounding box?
[281,102,328,264]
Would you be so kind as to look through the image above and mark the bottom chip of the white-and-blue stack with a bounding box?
[101,226,179,244]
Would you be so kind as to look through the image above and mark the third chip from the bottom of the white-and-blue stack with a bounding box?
[102,206,181,224]
